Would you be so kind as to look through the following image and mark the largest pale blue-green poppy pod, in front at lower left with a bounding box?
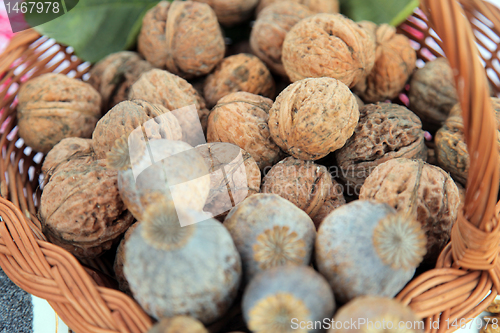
[124,202,241,324]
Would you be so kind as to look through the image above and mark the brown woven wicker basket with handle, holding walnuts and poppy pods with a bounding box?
[0,0,500,333]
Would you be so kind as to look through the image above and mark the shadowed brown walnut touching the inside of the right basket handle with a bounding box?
[408,58,458,127]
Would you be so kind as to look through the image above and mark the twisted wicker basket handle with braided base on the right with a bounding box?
[397,0,500,332]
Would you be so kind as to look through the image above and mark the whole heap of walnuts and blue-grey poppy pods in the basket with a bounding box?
[17,0,500,333]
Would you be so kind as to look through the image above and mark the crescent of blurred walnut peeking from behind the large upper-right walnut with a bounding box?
[250,1,313,77]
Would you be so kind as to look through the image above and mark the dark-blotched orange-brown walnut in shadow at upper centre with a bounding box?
[203,53,276,107]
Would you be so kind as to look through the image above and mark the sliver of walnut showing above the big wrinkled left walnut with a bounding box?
[42,138,94,177]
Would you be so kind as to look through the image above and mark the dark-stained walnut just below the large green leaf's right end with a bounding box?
[88,51,153,113]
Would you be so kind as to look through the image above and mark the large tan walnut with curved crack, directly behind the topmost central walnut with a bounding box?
[282,14,375,87]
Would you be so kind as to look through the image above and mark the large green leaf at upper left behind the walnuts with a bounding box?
[25,0,159,63]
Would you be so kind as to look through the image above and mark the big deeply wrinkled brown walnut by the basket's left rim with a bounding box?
[40,155,133,258]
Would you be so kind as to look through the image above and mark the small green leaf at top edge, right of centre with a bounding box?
[340,0,419,26]
